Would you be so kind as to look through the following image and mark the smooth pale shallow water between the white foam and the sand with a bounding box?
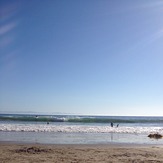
[0,131,163,144]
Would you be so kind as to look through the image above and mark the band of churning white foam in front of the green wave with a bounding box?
[0,124,163,134]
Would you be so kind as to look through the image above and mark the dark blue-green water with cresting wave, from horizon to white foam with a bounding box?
[0,115,163,123]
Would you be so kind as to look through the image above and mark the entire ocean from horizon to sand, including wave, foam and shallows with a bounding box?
[0,114,163,144]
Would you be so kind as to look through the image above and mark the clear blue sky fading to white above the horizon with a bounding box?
[0,0,163,116]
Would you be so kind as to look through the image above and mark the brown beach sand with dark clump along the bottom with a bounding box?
[0,143,163,163]
